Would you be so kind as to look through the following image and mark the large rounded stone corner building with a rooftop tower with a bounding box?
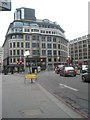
[3,8,68,69]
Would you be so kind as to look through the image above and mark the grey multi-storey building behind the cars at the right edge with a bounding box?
[69,34,90,65]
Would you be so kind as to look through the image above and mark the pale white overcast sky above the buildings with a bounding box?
[0,0,89,46]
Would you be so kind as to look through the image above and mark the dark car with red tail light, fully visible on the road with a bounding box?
[60,66,76,76]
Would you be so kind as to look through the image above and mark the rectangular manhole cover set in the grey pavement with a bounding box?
[22,108,42,117]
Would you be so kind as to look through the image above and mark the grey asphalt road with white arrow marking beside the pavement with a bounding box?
[38,71,90,116]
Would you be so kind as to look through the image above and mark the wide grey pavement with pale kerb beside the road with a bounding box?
[2,74,83,119]
